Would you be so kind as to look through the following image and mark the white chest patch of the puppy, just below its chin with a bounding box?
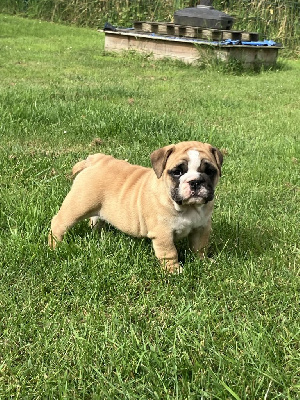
[173,205,211,240]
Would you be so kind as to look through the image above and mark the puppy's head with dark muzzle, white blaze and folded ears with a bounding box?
[151,142,223,205]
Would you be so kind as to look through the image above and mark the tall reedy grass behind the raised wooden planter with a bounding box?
[0,0,300,51]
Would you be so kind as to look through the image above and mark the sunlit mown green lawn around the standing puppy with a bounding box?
[0,16,300,400]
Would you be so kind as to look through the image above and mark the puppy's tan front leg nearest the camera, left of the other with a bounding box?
[152,235,182,273]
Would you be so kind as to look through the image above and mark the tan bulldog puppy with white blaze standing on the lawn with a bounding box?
[48,141,223,272]
